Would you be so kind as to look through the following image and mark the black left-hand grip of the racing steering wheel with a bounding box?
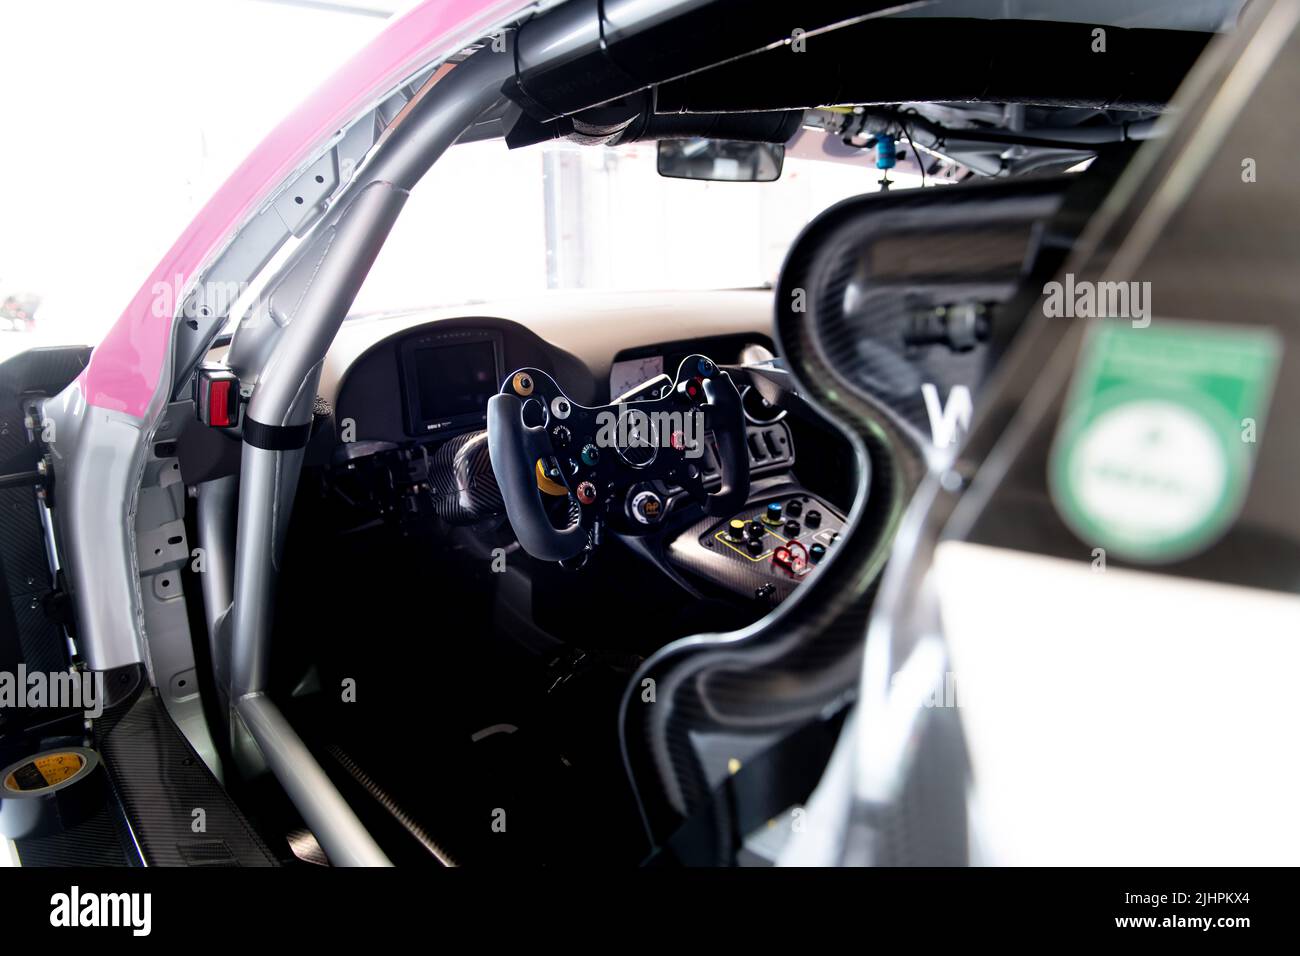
[488,394,588,561]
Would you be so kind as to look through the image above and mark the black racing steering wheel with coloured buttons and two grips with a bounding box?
[488,355,749,561]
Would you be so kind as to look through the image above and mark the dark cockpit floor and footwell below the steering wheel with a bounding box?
[276,481,762,865]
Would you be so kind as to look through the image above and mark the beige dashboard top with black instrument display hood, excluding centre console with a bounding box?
[320,290,772,444]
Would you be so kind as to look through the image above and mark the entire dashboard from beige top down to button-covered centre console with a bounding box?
[310,290,846,602]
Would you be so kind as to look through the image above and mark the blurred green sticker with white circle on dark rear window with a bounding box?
[1049,320,1281,562]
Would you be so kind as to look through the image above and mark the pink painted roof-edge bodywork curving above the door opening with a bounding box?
[79,0,529,419]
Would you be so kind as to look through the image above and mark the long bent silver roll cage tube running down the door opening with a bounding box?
[222,33,515,866]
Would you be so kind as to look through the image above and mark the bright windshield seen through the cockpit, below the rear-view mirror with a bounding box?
[352,134,919,315]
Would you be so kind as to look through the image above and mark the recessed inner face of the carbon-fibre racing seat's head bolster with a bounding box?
[803,177,1067,441]
